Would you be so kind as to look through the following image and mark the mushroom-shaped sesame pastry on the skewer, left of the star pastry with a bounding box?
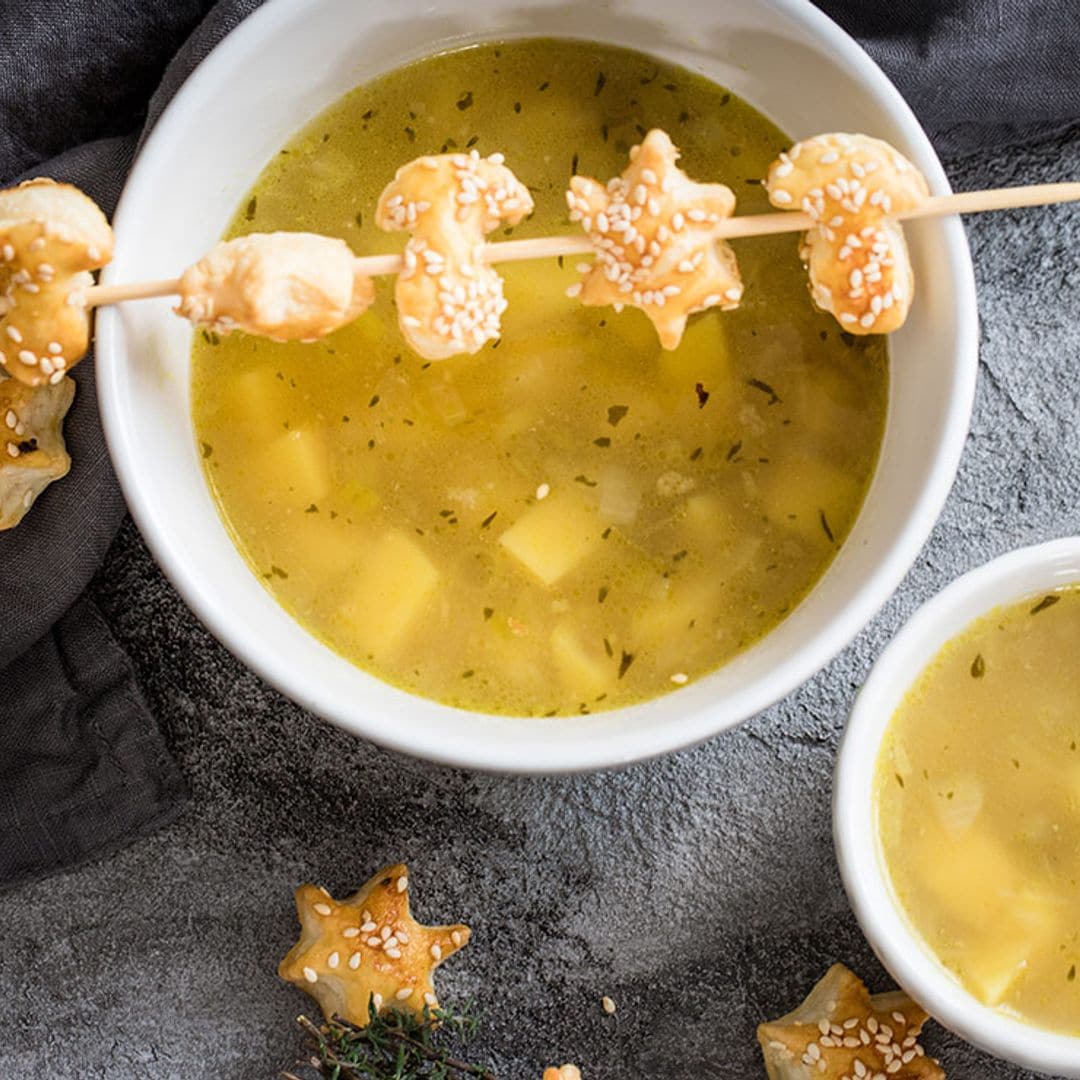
[375,150,532,360]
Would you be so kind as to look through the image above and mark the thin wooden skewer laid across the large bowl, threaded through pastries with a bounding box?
[83,181,1080,308]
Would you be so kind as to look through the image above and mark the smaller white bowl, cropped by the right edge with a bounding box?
[833,537,1080,1077]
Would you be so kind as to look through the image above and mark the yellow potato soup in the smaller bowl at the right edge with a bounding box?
[876,588,1080,1035]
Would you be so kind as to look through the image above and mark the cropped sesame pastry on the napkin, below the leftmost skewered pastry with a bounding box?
[0,375,75,529]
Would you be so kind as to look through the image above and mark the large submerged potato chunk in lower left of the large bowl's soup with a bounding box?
[341,531,438,657]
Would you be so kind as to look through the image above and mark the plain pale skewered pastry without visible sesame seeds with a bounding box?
[176,232,375,341]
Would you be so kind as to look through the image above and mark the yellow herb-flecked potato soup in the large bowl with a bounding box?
[193,40,888,715]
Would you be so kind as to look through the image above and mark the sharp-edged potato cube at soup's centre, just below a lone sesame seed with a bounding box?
[499,494,604,585]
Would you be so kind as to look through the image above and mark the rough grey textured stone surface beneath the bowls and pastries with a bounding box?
[0,76,1080,1080]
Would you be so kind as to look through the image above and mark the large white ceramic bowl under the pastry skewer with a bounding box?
[97,0,977,772]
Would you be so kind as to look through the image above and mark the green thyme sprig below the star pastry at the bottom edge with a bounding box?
[282,1001,497,1080]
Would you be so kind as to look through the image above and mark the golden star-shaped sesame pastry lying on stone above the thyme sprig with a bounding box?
[278,863,471,1027]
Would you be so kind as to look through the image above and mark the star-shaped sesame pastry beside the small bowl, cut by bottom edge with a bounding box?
[757,963,945,1080]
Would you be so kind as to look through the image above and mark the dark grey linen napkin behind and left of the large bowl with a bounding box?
[0,0,1080,887]
